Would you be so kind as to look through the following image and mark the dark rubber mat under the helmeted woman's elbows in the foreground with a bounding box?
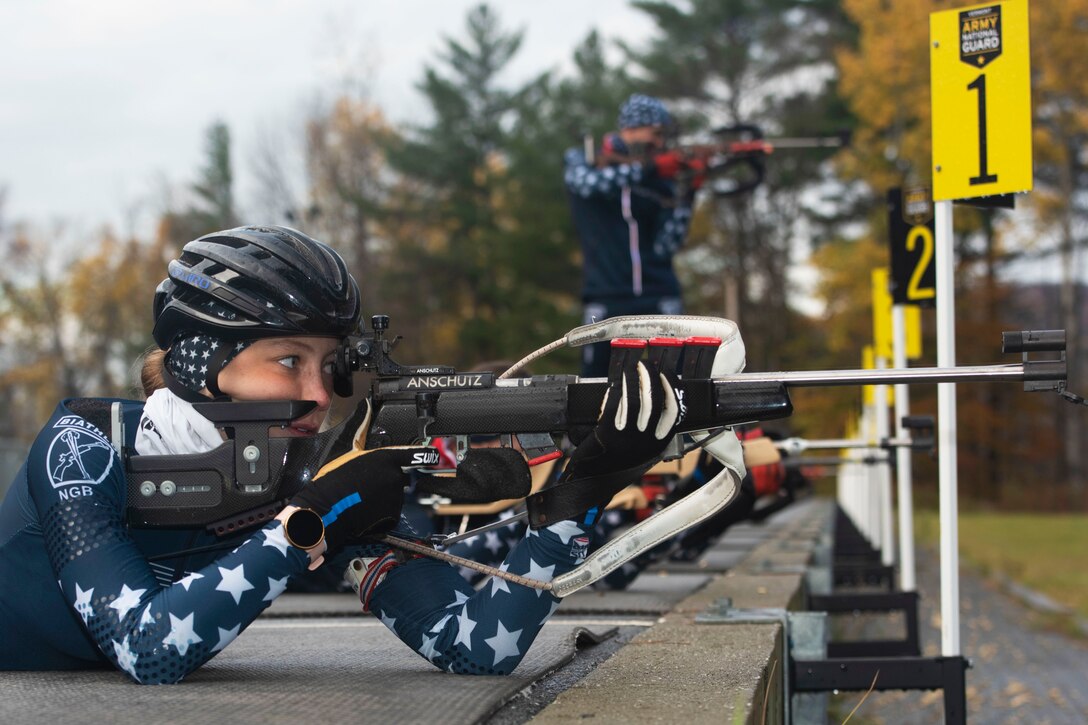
[0,617,607,725]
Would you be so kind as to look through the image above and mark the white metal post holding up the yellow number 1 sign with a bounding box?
[934,201,960,656]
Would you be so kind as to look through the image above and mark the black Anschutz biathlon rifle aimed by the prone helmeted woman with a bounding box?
[126,316,1066,597]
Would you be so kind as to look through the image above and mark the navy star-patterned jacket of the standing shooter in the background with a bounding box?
[564,135,693,302]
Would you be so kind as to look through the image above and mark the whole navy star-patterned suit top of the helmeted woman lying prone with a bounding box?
[0,401,589,684]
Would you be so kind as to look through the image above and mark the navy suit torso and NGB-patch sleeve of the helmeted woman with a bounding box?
[0,401,309,684]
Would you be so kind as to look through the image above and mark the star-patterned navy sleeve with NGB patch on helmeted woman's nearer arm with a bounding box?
[32,433,308,684]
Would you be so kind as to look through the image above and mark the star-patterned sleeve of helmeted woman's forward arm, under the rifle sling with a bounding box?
[370,521,592,675]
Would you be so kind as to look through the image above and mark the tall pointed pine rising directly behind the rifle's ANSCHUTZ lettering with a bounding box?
[378,4,522,364]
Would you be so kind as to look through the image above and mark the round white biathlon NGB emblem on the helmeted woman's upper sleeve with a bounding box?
[46,416,113,499]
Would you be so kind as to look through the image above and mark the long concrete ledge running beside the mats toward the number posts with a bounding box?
[531,502,831,724]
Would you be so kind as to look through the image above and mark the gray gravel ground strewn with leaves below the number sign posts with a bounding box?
[830,550,1088,725]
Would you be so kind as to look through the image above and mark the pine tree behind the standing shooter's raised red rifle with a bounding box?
[627,0,851,369]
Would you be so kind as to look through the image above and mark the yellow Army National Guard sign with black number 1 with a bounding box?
[929,0,1031,201]
